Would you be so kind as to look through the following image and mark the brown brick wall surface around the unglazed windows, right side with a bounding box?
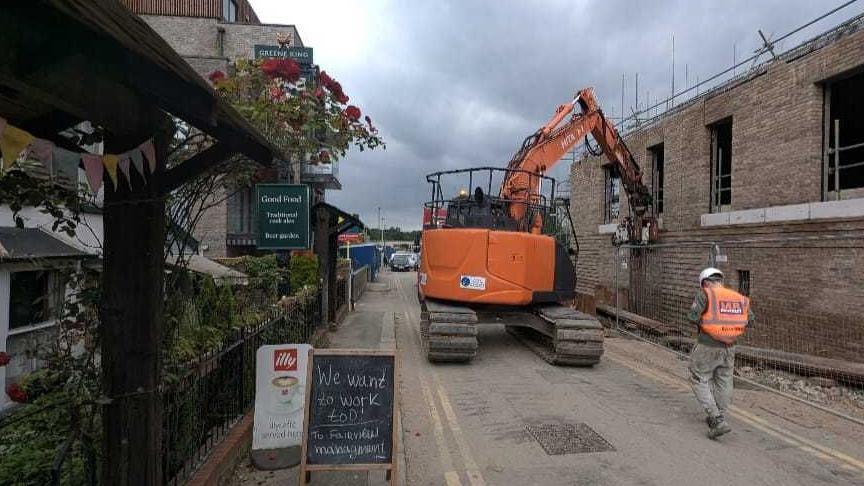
[571,24,864,360]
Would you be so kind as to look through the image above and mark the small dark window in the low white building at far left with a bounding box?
[9,270,54,329]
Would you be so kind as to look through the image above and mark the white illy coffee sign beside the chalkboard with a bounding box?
[252,344,312,460]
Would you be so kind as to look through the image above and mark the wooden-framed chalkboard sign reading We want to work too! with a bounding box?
[300,349,398,484]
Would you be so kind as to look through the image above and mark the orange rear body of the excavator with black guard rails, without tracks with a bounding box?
[419,167,575,306]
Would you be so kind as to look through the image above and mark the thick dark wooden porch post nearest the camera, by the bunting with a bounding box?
[101,127,169,486]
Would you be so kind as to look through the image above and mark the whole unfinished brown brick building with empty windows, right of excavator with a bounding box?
[570,16,864,361]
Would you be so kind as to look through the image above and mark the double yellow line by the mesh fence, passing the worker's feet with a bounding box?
[604,350,864,473]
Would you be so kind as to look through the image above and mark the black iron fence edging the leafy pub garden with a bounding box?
[0,289,321,486]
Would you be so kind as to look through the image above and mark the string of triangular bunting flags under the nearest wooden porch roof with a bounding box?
[0,118,156,193]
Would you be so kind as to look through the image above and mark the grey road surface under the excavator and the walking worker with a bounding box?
[235,272,864,486]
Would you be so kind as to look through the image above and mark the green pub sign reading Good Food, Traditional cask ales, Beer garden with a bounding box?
[255,184,310,250]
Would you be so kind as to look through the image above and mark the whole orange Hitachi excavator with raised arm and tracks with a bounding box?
[418,88,656,366]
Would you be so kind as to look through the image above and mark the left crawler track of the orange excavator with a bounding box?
[420,300,478,363]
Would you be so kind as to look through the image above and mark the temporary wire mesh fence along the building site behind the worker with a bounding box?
[598,235,864,423]
